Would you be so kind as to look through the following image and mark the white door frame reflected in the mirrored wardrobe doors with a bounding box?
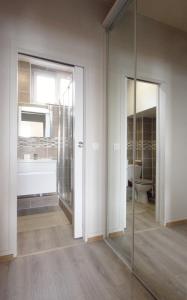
[121,75,165,225]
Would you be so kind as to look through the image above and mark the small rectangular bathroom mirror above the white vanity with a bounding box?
[18,105,51,138]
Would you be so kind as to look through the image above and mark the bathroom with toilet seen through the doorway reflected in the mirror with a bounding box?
[126,78,159,236]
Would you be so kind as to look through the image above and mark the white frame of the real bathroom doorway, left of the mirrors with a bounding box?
[10,44,86,257]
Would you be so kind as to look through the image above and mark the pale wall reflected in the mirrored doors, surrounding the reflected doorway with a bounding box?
[108,7,187,231]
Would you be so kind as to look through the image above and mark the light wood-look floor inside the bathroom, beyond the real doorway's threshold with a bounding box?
[18,208,83,256]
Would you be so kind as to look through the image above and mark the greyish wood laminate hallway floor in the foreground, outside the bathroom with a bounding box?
[0,241,155,300]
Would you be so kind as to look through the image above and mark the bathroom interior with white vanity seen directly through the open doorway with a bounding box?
[17,54,79,255]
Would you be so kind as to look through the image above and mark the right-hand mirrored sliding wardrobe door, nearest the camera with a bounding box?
[133,0,187,300]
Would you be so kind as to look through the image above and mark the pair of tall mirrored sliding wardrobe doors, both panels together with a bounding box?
[106,0,187,300]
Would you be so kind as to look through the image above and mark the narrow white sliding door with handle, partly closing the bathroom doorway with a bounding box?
[73,67,84,238]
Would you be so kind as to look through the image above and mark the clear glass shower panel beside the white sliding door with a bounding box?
[58,83,73,214]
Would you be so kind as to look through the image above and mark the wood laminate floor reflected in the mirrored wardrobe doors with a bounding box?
[108,203,187,300]
